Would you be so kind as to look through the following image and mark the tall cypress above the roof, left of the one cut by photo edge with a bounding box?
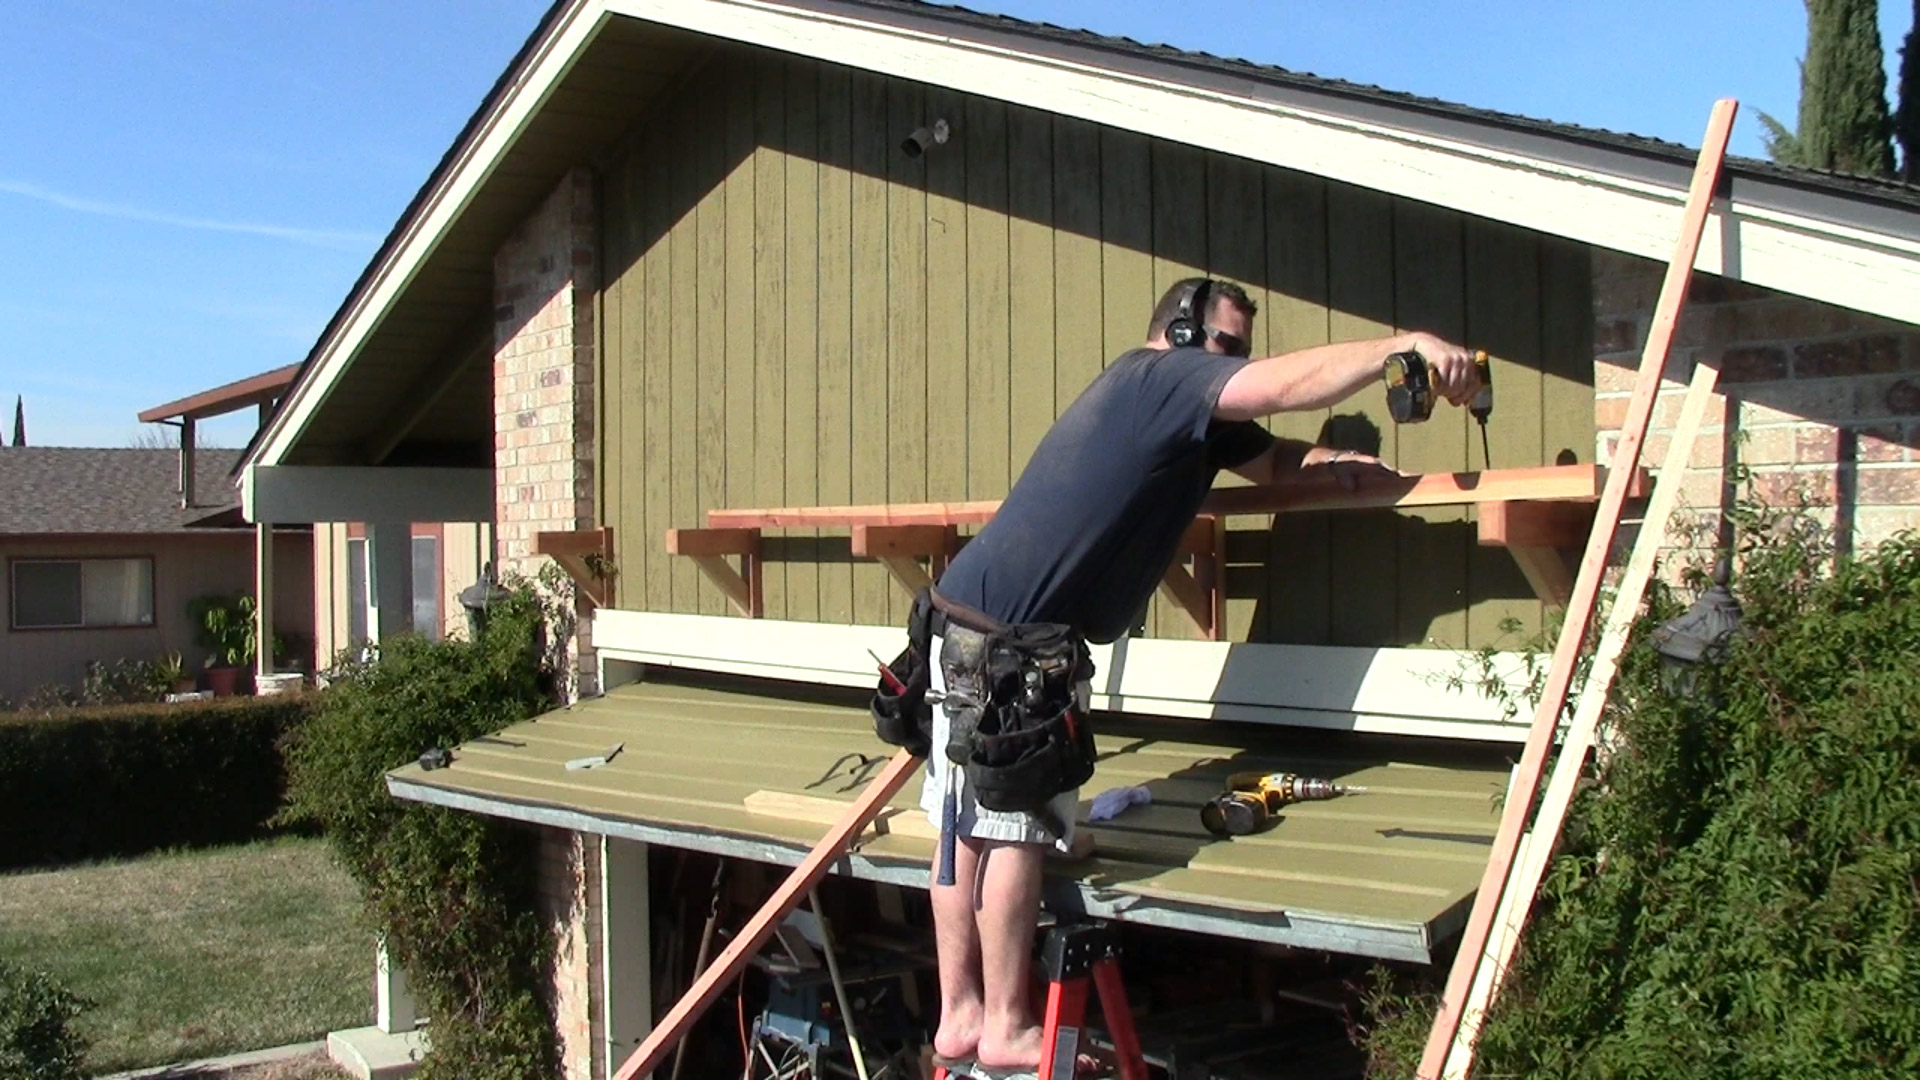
[1761,0,1893,177]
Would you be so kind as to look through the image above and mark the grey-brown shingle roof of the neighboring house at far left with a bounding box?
[0,446,240,536]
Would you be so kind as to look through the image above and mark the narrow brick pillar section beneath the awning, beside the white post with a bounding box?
[540,828,607,1080]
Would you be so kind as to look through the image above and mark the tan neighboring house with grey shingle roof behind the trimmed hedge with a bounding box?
[0,446,313,701]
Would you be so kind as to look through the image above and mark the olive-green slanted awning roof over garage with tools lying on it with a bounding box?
[390,680,1507,959]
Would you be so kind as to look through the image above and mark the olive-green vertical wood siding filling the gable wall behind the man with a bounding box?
[597,52,1592,646]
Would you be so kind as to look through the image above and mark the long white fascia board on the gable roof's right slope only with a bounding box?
[607,0,1920,323]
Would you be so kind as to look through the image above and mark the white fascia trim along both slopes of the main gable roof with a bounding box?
[253,0,1920,465]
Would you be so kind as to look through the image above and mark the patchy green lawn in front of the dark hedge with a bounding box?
[0,838,372,1072]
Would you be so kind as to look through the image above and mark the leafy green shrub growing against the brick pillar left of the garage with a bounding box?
[286,588,559,1080]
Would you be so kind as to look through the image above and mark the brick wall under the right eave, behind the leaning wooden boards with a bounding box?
[1594,252,1920,552]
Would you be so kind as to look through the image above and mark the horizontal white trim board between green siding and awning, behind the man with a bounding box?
[593,609,1532,742]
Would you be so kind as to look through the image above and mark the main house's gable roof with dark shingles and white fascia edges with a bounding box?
[244,0,1920,465]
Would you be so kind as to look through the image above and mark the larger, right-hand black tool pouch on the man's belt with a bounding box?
[948,623,1094,813]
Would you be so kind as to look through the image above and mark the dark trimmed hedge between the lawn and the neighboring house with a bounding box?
[0,694,311,869]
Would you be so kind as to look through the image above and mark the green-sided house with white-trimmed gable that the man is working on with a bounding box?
[242,0,1920,1078]
